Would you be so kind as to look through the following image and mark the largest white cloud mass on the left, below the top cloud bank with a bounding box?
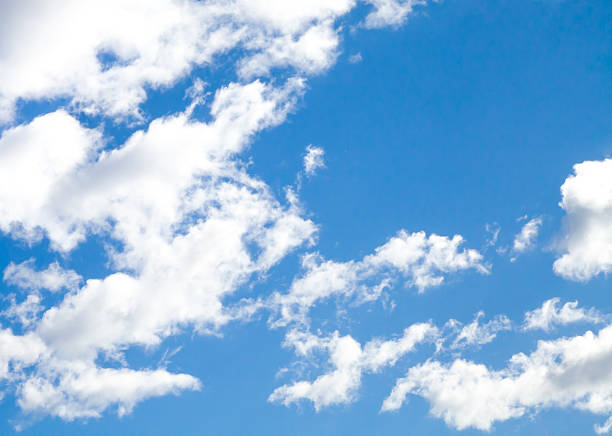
[0,80,316,419]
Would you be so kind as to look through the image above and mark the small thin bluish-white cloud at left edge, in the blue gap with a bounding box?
[4,259,82,292]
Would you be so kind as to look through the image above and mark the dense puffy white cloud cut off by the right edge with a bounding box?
[554,159,612,280]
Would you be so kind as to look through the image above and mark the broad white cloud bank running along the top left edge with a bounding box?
[0,0,354,121]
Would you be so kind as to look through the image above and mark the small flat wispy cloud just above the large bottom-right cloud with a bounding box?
[523,298,605,331]
